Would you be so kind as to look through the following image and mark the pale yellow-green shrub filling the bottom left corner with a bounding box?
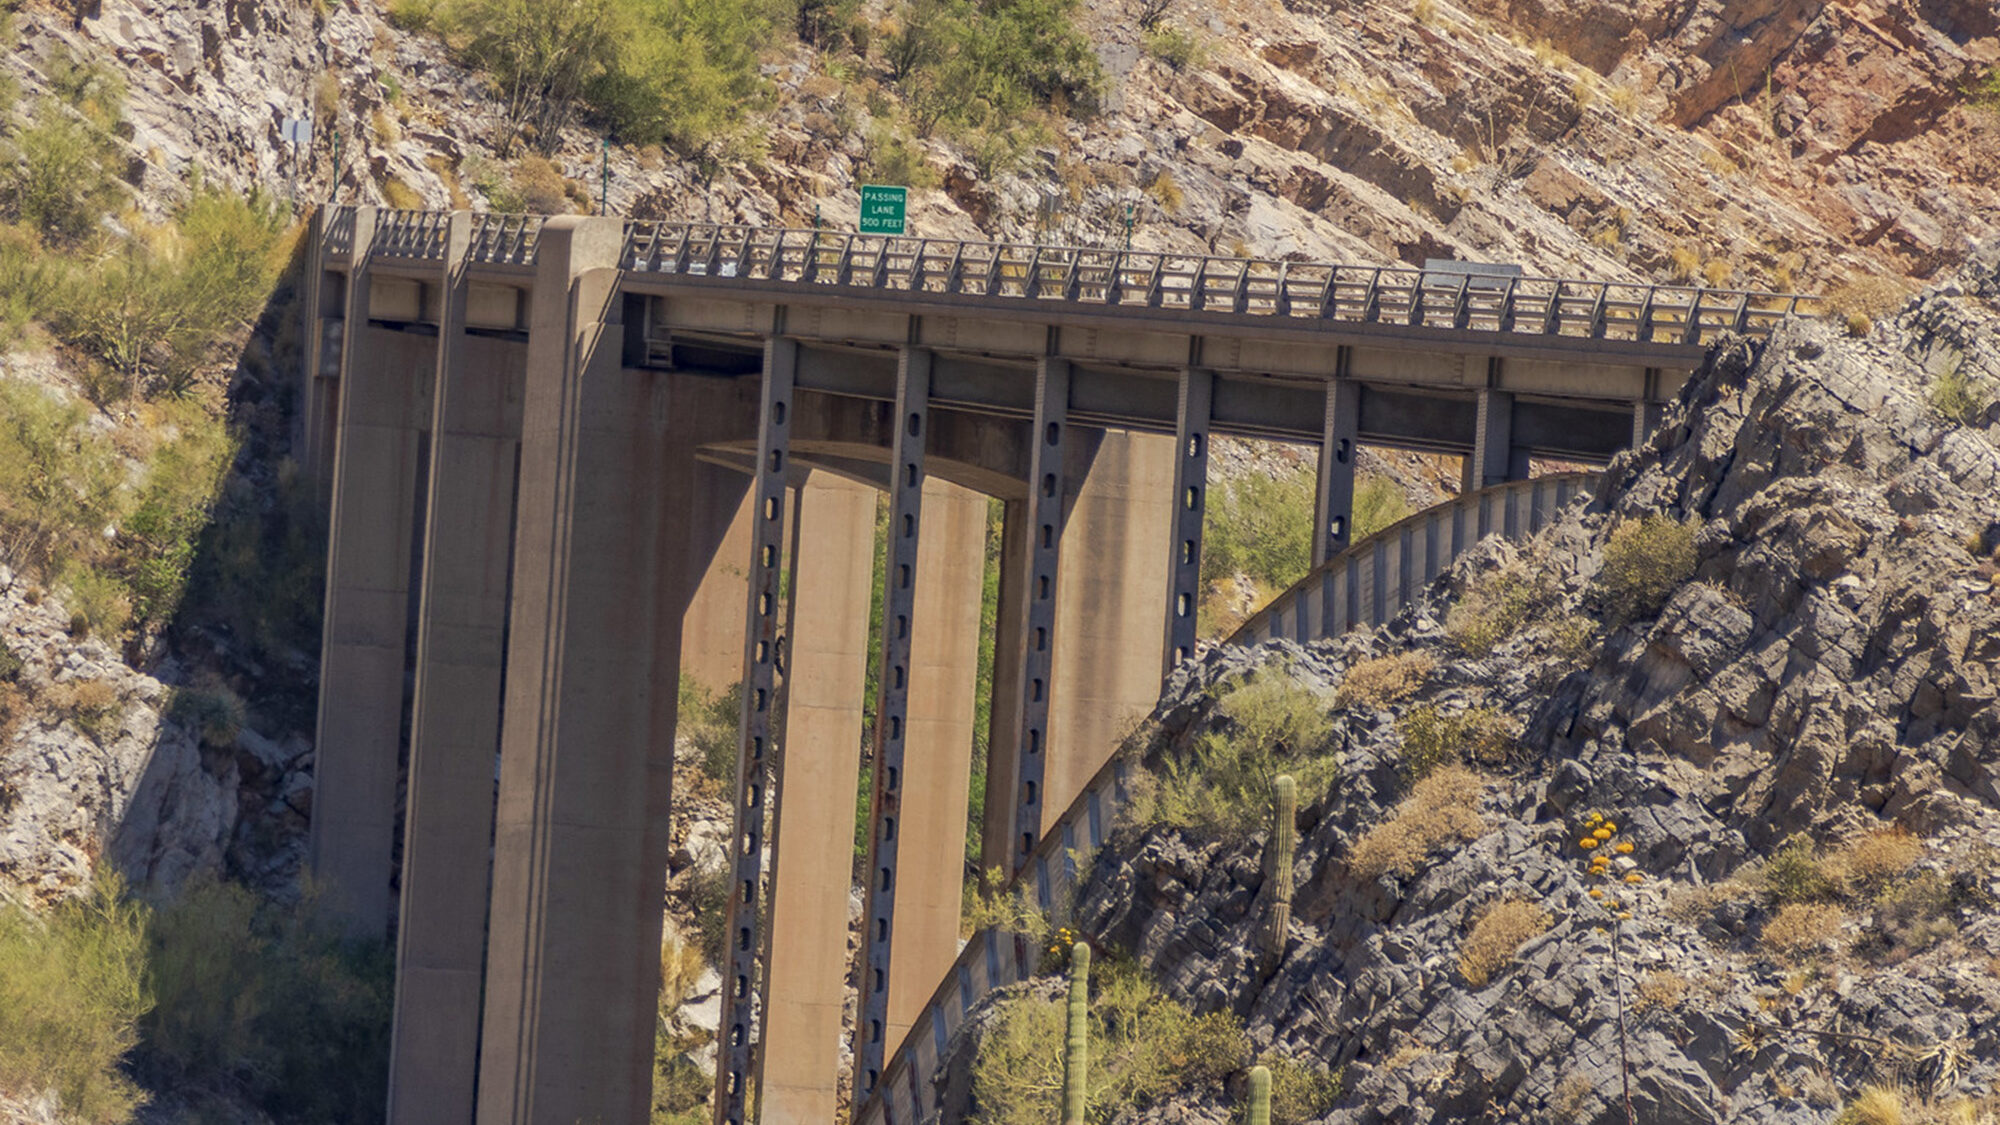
[0,873,152,1125]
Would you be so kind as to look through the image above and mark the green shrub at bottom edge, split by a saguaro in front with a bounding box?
[972,944,1248,1125]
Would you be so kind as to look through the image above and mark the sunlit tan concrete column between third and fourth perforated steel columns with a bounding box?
[1036,430,1176,837]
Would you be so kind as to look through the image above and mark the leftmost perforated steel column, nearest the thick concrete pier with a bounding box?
[716,336,798,1125]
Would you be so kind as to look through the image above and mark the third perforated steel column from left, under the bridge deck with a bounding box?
[1008,356,1070,873]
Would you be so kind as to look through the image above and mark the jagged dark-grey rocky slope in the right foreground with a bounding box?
[952,256,2000,1125]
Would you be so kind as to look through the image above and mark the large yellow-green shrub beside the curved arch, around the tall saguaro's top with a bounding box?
[1130,669,1340,841]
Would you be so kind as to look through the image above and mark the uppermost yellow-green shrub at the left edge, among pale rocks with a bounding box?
[0,102,118,242]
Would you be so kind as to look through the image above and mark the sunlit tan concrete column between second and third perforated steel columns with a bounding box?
[888,476,986,1055]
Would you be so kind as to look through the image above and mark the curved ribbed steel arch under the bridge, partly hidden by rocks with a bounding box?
[854,472,1600,1125]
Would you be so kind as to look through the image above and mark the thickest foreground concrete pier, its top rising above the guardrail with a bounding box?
[478,216,742,1125]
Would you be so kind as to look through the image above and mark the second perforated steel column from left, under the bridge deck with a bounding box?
[854,348,930,1105]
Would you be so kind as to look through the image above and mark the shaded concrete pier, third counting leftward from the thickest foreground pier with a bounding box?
[308,208,436,939]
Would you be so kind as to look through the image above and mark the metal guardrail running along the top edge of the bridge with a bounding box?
[312,206,1820,346]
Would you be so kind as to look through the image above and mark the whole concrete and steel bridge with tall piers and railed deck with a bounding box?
[300,208,1798,1125]
